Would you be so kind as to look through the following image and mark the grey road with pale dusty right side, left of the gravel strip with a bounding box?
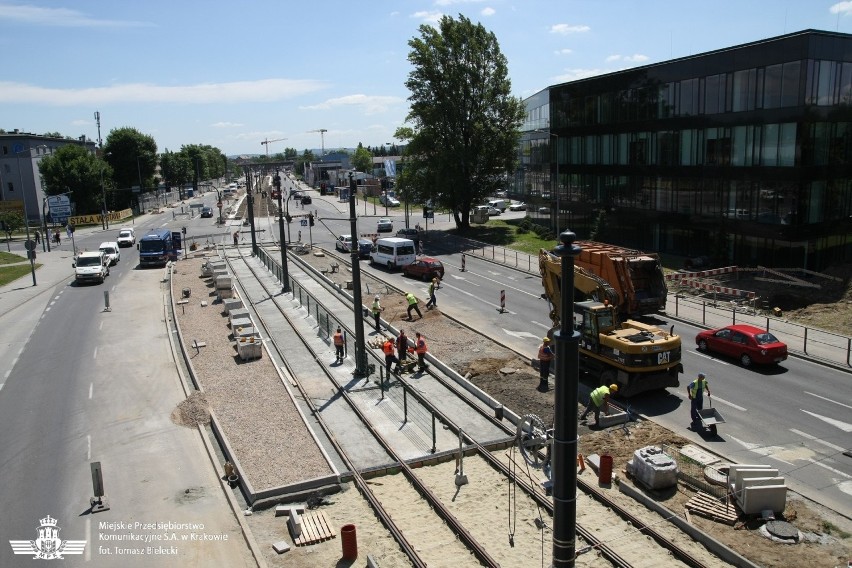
[0,216,255,567]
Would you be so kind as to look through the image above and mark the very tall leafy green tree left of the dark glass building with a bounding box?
[402,15,525,231]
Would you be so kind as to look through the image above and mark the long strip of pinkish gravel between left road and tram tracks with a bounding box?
[171,256,333,491]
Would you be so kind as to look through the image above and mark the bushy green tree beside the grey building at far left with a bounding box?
[38,144,112,215]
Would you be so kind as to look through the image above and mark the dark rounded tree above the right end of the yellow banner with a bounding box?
[101,126,157,209]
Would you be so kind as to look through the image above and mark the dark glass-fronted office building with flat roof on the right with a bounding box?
[513,30,852,270]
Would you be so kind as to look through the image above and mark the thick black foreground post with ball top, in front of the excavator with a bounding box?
[553,231,581,568]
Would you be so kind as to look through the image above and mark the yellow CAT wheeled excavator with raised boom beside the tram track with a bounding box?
[539,249,683,397]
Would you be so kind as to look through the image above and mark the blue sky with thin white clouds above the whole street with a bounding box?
[0,0,852,155]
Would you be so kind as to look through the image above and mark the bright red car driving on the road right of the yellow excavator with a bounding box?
[695,324,787,367]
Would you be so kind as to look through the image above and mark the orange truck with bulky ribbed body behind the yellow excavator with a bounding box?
[574,241,668,317]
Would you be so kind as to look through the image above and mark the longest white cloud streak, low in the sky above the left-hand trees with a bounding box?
[0,79,326,106]
